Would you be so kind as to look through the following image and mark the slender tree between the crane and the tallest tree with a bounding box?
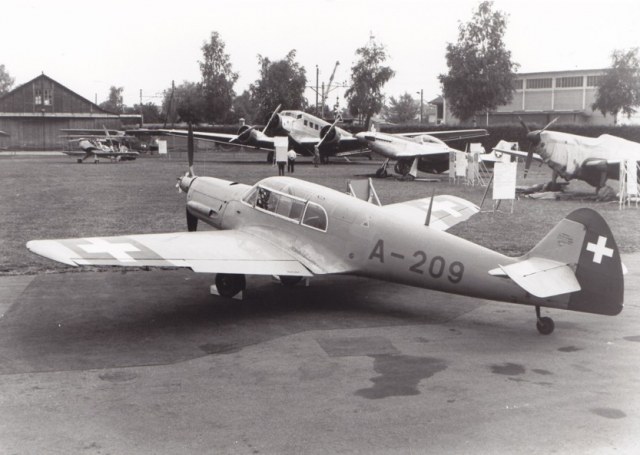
[345,37,395,129]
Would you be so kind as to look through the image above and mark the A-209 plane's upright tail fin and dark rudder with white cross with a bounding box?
[527,208,624,316]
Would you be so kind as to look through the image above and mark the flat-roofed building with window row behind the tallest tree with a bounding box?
[440,69,614,126]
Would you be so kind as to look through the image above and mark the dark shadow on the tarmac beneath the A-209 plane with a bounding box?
[0,271,482,373]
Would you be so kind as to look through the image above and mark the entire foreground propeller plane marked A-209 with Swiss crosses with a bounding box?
[27,135,624,334]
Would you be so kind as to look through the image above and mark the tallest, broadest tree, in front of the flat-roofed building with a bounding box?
[438,1,518,121]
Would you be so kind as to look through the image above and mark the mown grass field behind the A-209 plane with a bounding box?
[0,149,640,275]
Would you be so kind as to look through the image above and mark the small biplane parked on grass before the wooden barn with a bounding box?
[62,128,140,163]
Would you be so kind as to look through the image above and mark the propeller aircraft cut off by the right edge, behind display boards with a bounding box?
[494,118,640,193]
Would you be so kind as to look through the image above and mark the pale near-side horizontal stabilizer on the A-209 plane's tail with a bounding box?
[489,257,581,298]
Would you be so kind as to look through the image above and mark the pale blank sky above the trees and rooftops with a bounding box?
[0,0,640,107]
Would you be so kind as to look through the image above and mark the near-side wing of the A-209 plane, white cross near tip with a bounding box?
[27,230,312,276]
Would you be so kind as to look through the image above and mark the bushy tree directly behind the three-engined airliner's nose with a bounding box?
[249,49,307,121]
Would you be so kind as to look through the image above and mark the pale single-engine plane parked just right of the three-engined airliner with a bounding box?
[356,129,489,178]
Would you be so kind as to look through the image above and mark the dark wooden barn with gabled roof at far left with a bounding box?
[0,74,122,150]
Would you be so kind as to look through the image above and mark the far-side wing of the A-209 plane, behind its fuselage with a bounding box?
[383,194,480,231]
